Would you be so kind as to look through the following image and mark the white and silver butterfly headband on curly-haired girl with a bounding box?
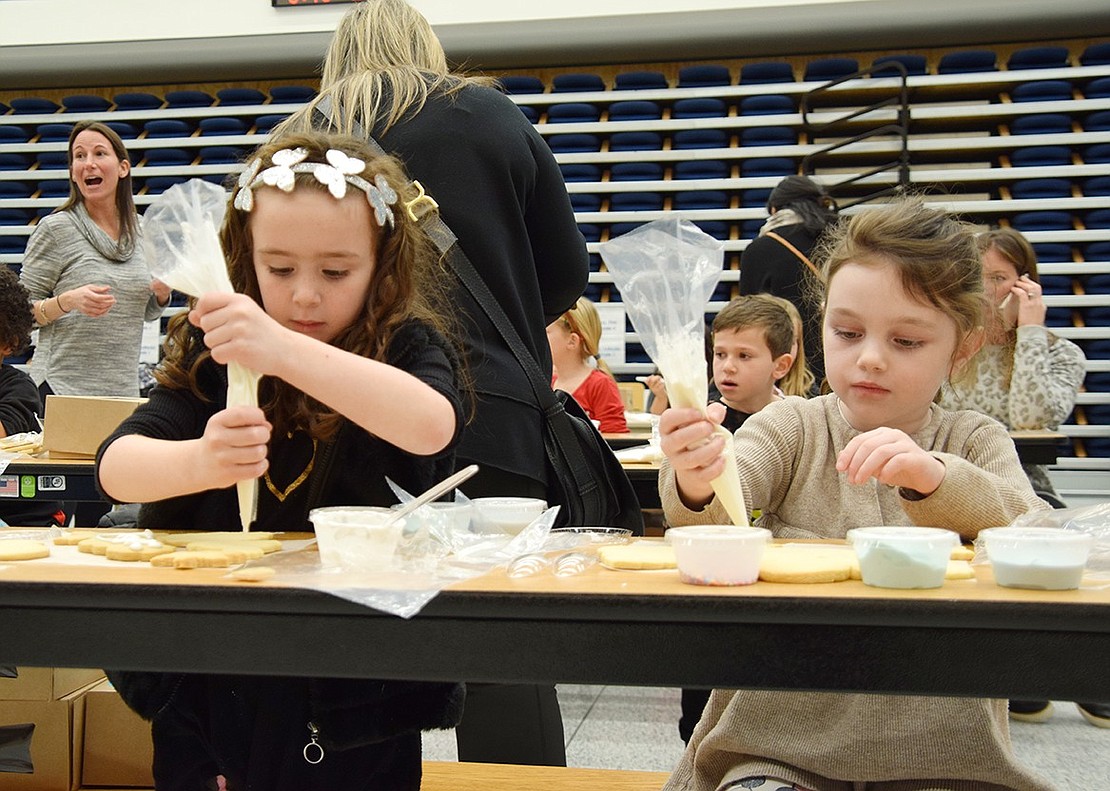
[233,148,397,227]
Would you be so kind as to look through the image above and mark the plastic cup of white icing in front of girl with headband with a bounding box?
[309,506,405,571]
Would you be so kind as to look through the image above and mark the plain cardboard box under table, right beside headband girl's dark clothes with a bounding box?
[81,681,154,788]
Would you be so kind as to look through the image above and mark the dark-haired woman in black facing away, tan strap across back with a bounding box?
[740,175,837,385]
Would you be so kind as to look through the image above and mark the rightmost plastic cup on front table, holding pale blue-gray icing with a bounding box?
[979,527,1094,590]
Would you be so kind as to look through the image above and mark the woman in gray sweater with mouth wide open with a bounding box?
[20,121,170,398]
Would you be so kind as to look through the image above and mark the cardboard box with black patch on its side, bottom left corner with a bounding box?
[0,689,84,791]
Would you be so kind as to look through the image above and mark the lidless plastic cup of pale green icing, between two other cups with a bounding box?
[848,527,960,588]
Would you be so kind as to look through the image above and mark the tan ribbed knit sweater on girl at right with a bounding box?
[659,395,1052,791]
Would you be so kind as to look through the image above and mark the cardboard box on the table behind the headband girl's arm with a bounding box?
[42,395,147,458]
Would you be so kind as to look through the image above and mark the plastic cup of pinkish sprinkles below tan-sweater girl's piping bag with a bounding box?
[667,525,770,585]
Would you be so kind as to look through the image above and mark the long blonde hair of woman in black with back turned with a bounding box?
[275,0,493,134]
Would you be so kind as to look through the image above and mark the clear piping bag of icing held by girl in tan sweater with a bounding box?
[598,216,748,525]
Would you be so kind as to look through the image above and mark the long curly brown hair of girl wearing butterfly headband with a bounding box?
[154,132,464,439]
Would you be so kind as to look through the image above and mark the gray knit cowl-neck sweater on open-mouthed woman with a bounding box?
[20,211,162,396]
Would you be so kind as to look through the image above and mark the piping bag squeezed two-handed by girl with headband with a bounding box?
[142,179,260,531]
